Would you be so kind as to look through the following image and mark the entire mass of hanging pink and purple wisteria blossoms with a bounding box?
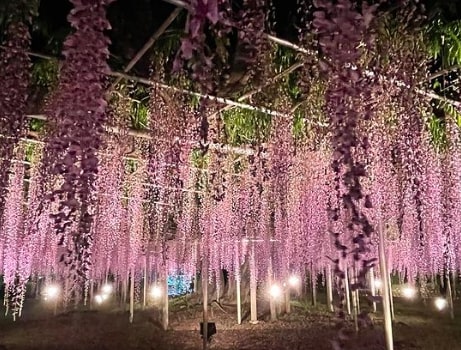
[0,0,461,330]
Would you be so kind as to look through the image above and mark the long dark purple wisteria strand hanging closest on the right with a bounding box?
[313,0,376,336]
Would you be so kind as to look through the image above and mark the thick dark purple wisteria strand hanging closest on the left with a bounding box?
[46,0,112,300]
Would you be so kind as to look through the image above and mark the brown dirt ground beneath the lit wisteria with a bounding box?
[0,301,461,350]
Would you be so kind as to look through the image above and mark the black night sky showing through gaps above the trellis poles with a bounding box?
[16,0,461,75]
